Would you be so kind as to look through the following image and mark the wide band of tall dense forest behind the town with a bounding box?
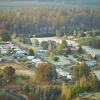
[0,6,100,34]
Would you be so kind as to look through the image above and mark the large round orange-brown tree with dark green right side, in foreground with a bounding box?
[35,62,57,85]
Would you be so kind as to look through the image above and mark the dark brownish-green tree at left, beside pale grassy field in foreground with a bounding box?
[3,66,15,82]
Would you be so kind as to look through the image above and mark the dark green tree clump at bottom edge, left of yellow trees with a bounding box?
[29,86,61,100]
